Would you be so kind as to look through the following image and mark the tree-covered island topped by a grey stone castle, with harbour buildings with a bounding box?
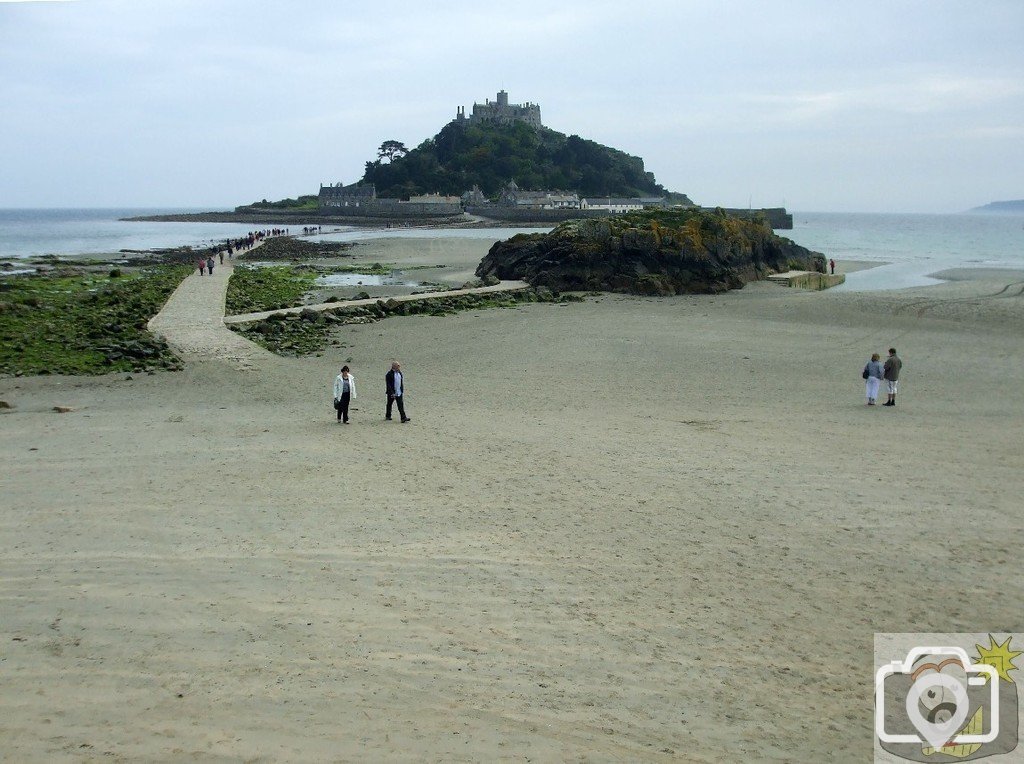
[128,90,793,228]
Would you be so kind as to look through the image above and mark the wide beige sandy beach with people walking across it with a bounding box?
[0,240,1024,762]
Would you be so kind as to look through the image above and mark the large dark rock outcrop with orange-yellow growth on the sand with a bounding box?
[476,210,825,295]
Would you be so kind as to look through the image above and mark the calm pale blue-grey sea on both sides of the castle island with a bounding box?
[0,209,1024,291]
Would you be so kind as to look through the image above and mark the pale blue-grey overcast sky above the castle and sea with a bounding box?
[0,0,1024,212]
